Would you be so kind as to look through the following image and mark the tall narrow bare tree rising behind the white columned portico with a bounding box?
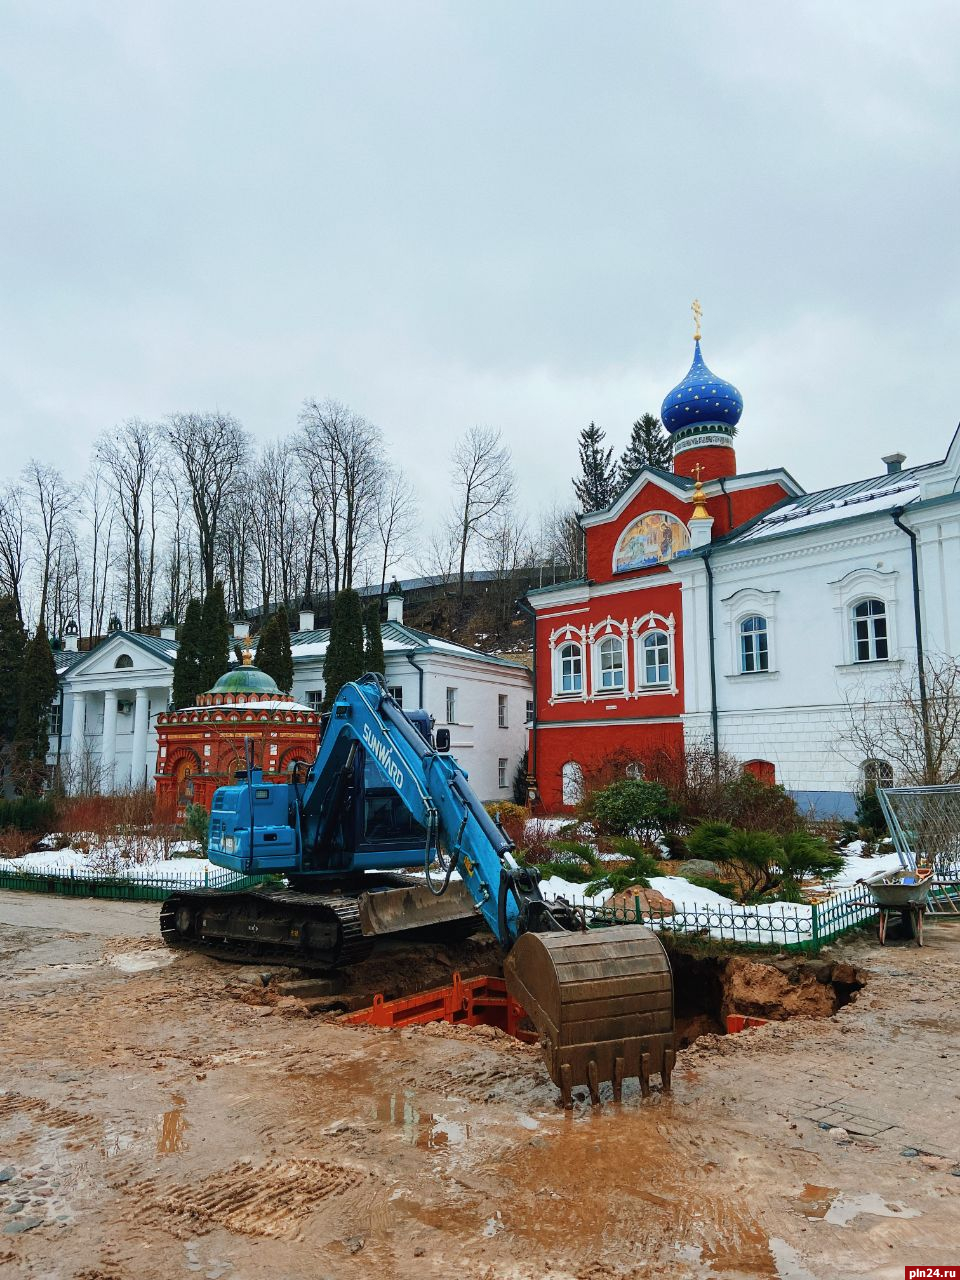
[96,417,163,631]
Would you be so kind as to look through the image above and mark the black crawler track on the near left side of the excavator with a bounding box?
[160,888,374,970]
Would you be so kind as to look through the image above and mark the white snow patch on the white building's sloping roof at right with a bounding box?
[723,462,938,545]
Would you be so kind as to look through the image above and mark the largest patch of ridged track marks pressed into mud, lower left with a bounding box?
[131,1158,372,1238]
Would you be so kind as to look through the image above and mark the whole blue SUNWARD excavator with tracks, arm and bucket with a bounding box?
[160,675,673,1106]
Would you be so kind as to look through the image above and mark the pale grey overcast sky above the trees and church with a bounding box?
[0,0,960,527]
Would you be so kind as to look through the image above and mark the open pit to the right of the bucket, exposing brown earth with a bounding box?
[669,945,867,1048]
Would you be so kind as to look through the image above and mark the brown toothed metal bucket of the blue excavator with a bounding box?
[503,924,675,1107]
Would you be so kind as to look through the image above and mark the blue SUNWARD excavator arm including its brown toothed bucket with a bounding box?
[308,676,673,1105]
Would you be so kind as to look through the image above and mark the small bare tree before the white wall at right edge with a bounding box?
[841,654,960,786]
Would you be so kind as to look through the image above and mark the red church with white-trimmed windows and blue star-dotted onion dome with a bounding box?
[527,313,800,810]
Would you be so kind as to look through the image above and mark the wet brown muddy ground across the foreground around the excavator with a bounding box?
[0,893,960,1280]
